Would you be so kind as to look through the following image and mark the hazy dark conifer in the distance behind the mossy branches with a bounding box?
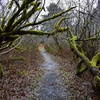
[41,3,63,46]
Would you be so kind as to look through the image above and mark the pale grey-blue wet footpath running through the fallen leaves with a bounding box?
[37,48,70,100]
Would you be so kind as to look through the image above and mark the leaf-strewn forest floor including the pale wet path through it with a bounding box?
[0,45,99,100]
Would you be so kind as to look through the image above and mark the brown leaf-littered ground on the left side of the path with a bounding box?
[0,49,42,100]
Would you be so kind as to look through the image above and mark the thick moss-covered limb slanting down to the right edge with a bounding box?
[68,30,100,88]
